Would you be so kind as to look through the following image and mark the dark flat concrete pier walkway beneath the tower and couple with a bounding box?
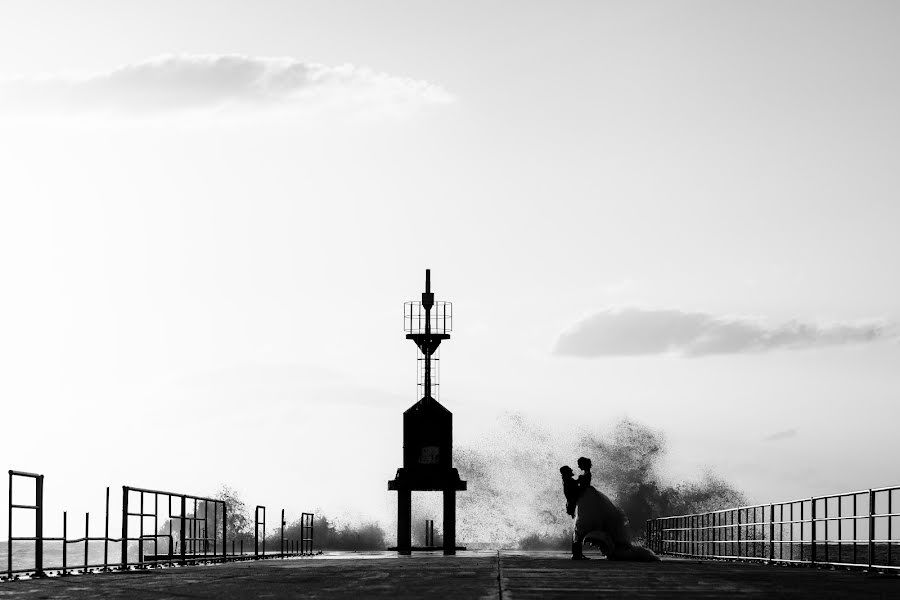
[0,551,900,600]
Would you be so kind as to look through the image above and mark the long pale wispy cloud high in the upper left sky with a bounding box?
[0,54,453,115]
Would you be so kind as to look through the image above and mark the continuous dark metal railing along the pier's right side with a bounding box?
[647,486,900,571]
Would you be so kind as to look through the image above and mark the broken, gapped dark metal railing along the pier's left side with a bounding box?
[0,470,313,581]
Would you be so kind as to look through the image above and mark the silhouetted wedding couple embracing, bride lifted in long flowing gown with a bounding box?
[559,456,659,561]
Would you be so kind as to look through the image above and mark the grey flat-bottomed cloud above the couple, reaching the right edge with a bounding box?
[554,308,897,357]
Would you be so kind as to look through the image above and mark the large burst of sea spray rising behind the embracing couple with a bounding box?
[454,414,745,548]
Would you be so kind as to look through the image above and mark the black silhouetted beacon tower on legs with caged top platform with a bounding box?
[388,269,466,554]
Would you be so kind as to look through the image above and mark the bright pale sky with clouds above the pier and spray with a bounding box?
[0,0,900,532]
